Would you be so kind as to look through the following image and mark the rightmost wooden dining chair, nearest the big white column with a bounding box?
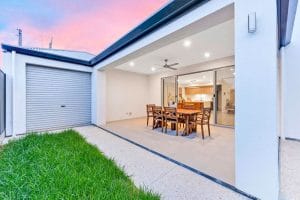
[190,108,211,139]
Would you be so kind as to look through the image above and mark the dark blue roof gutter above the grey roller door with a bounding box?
[1,44,92,67]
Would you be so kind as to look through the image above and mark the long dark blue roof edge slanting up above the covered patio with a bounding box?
[90,0,210,65]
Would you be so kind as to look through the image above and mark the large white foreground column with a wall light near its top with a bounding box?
[235,0,279,200]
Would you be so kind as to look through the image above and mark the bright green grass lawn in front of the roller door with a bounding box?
[0,130,159,200]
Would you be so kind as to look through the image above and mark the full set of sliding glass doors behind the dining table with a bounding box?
[162,66,235,127]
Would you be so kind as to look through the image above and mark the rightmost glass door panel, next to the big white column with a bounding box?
[215,67,235,126]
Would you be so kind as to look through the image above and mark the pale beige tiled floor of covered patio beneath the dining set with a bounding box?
[106,118,235,185]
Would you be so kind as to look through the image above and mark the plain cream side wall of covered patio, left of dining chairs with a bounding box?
[106,70,149,122]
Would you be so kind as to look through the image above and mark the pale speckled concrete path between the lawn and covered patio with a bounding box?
[74,126,248,200]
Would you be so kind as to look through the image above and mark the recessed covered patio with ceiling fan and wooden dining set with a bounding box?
[101,5,235,186]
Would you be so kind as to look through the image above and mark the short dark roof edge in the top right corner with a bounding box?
[277,0,298,47]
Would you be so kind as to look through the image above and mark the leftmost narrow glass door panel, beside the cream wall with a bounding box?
[162,76,177,107]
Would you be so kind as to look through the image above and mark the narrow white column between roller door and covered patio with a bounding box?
[92,68,106,126]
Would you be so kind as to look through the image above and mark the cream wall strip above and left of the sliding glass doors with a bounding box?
[149,56,234,105]
